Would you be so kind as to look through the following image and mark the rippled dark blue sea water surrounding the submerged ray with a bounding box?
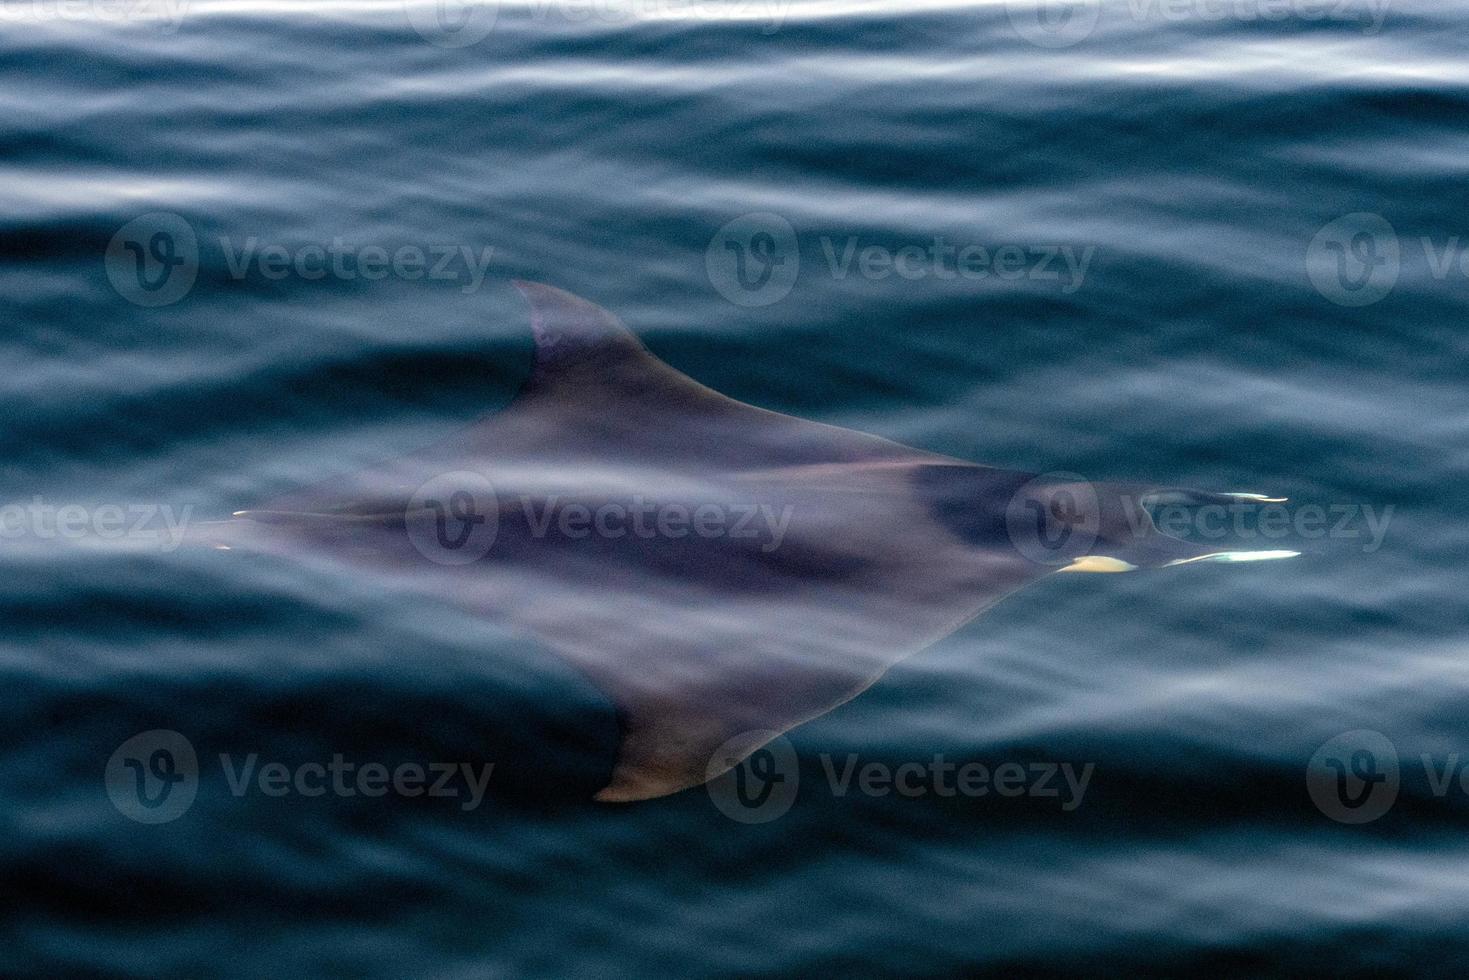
[0,0,1469,977]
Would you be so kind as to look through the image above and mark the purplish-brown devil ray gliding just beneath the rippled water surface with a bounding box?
[210,284,1292,801]
